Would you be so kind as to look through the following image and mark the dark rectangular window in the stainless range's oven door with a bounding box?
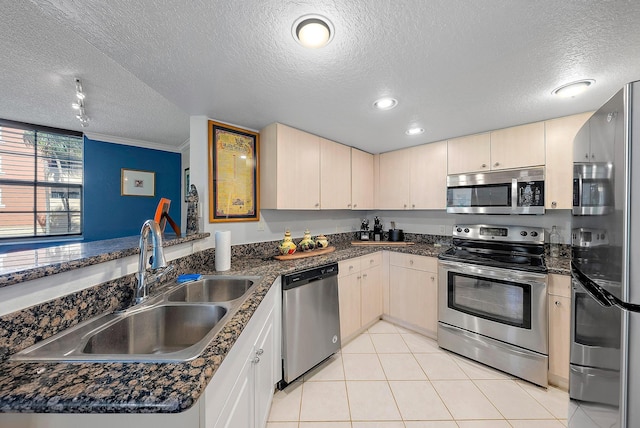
[447,272,531,329]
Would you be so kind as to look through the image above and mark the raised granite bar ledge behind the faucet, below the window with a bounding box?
[0,233,210,287]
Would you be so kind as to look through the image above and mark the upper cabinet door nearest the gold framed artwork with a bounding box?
[277,124,320,210]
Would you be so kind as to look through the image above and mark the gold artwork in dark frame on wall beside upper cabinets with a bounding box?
[209,120,260,223]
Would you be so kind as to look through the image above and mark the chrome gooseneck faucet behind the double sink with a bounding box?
[133,220,173,305]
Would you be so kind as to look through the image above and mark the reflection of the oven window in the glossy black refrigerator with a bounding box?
[573,292,621,349]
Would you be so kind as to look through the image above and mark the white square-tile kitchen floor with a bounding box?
[267,321,569,428]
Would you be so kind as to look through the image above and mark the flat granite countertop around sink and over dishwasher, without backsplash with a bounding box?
[0,243,446,413]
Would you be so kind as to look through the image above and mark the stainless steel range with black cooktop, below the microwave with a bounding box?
[438,225,549,386]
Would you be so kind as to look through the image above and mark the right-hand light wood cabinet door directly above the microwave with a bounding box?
[491,122,545,170]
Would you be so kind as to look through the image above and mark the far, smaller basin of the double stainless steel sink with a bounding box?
[167,277,255,302]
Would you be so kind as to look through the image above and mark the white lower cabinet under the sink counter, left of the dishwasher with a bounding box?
[0,277,282,428]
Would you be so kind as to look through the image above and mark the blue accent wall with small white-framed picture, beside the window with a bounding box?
[84,137,182,242]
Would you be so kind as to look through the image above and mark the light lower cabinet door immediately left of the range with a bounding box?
[389,266,437,329]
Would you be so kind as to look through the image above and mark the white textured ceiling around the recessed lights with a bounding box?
[0,0,640,153]
